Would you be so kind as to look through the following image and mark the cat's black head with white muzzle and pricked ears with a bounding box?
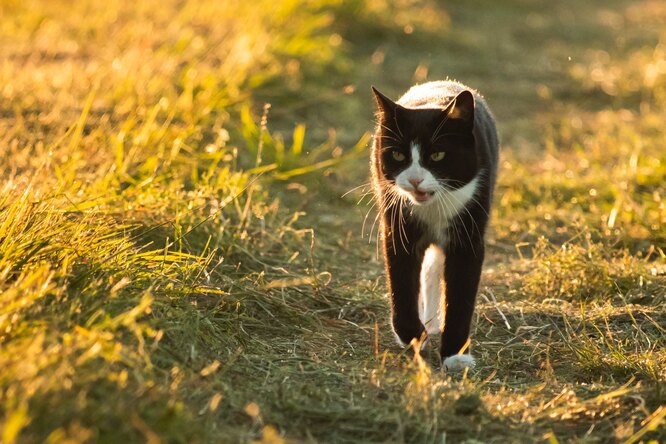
[372,87,479,205]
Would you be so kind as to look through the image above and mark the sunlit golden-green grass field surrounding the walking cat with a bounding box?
[0,0,666,444]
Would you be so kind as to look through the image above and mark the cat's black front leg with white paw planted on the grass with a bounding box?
[440,240,484,371]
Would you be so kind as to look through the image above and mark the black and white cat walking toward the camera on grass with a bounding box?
[371,81,499,371]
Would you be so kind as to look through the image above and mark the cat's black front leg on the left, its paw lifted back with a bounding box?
[384,218,425,345]
